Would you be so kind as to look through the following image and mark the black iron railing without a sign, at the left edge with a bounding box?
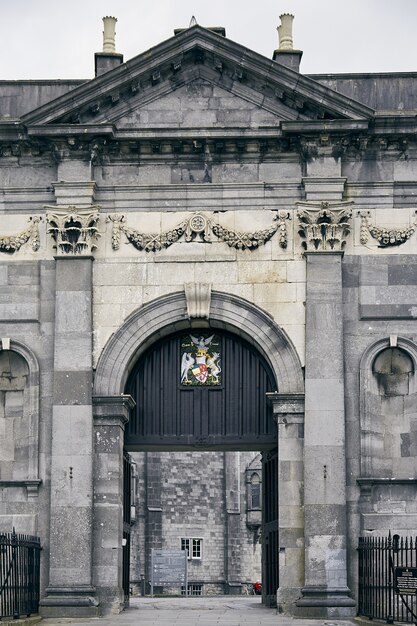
[0,529,41,619]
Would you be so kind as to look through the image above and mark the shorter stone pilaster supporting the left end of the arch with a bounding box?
[93,395,135,613]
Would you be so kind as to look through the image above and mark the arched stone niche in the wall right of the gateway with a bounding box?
[360,337,417,479]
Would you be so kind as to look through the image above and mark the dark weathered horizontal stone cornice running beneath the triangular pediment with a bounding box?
[4,123,417,158]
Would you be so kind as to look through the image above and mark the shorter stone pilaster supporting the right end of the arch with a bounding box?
[267,392,304,614]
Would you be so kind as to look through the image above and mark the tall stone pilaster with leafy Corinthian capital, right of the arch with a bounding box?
[297,203,355,618]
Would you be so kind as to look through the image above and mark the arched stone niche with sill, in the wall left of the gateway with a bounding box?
[0,340,41,496]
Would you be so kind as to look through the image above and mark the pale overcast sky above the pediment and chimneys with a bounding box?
[0,0,417,80]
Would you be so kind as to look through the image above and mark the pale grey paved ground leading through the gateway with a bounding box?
[39,596,357,626]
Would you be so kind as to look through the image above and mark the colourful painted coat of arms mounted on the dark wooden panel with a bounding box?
[181,335,222,385]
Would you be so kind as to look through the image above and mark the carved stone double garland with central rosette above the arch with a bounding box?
[107,210,291,252]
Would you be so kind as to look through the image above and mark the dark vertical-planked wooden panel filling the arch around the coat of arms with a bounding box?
[125,328,277,451]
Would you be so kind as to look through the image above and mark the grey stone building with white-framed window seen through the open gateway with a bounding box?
[130,451,262,595]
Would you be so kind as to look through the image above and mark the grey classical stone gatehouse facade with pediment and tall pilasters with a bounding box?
[0,16,417,617]
